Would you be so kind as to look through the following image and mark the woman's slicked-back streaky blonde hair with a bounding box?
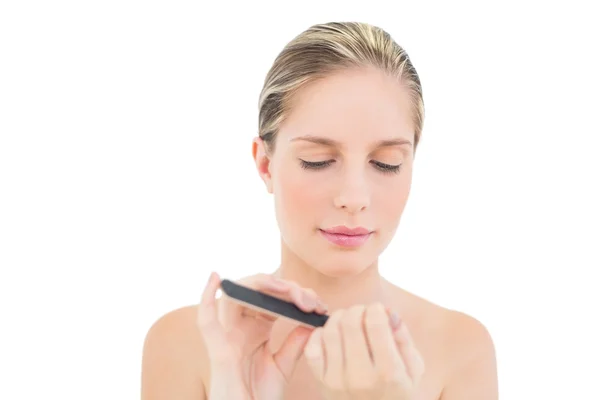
[258,22,425,152]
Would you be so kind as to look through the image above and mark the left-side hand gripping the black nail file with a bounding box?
[198,273,326,400]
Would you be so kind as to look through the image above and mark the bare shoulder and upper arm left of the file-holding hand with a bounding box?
[141,307,206,400]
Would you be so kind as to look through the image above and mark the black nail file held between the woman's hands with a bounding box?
[221,279,329,328]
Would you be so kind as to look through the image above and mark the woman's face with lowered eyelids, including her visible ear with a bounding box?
[253,69,414,277]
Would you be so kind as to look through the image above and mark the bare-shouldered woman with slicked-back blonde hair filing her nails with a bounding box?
[142,23,498,400]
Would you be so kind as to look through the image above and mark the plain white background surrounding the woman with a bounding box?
[0,0,600,399]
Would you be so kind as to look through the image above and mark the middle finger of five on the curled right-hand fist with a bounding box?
[340,305,375,382]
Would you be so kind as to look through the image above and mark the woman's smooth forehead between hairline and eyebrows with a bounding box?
[279,68,414,147]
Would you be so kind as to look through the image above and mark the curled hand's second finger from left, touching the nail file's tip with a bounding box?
[323,310,346,390]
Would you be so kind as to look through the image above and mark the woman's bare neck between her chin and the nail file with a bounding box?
[273,239,389,314]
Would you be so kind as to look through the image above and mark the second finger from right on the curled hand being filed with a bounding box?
[365,303,406,381]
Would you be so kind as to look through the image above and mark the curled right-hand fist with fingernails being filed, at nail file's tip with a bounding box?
[304,304,425,400]
